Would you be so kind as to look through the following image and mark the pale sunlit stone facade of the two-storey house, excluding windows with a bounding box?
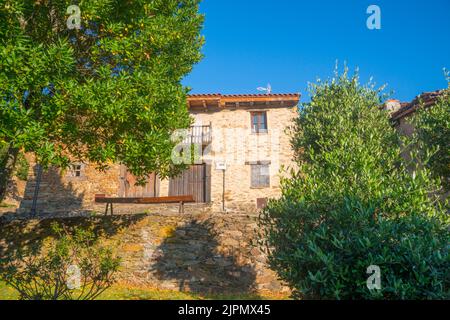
[161,97,298,212]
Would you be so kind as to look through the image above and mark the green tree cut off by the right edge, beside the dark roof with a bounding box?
[414,74,450,192]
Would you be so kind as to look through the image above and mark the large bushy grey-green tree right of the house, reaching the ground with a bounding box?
[260,71,450,299]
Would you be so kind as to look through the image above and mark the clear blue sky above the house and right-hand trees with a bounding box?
[183,0,450,101]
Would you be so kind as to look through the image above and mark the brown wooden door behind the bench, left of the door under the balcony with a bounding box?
[119,166,159,198]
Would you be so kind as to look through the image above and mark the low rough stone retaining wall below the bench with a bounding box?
[0,214,289,295]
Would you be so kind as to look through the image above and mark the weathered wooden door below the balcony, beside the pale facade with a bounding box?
[169,164,211,203]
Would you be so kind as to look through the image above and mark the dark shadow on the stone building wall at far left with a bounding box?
[19,166,84,215]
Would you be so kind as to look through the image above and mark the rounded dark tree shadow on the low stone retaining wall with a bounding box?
[150,221,256,294]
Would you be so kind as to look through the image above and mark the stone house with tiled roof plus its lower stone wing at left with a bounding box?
[6,94,300,213]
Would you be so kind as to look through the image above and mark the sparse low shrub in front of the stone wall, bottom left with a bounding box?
[0,224,120,300]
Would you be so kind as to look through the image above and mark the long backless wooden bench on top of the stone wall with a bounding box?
[95,194,195,215]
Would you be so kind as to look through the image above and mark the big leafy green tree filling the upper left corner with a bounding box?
[0,0,203,198]
